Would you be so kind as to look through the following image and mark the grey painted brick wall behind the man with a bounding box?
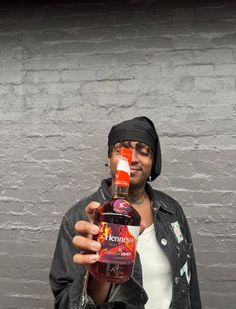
[0,0,236,309]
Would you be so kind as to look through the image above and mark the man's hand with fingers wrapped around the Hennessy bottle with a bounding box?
[73,202,101,269]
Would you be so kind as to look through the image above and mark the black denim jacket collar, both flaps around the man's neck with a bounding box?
[98,178,175,214]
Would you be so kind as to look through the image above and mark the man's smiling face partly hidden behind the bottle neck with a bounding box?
[108,141,153,189]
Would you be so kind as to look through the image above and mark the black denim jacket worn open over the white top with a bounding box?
[50,179,202,309]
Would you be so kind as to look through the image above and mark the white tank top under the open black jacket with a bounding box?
[137,224,172,309]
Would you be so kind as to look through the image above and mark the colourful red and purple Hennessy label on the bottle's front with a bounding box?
[97,222,140,264]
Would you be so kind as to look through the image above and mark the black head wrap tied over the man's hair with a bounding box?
[108,117,161,181]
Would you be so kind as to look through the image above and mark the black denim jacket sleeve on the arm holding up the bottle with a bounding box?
[49,217,96,309]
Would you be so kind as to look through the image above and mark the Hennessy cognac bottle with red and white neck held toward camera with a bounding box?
[90,148,141,283]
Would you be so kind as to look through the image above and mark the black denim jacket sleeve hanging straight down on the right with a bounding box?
[179,206,202,309]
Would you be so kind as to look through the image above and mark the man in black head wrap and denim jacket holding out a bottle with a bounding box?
[50,117,201,309]
